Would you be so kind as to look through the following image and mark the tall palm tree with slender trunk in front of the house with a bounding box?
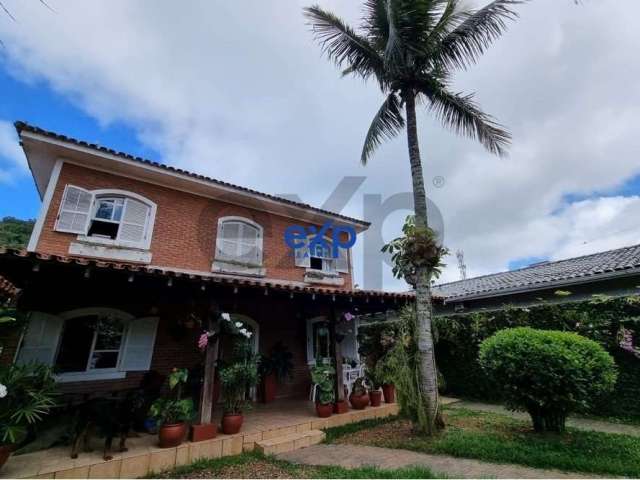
[304,0,522,433]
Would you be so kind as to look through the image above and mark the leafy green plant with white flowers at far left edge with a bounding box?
[0,363,57,467]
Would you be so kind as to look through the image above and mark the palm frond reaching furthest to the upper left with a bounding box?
[304,5,384,83]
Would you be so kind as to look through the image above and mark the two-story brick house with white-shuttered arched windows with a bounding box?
[0,122,410,404]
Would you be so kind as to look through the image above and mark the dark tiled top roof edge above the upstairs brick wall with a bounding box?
[14,121,371,229]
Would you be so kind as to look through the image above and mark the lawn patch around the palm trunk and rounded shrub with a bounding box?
[326,408,640,477]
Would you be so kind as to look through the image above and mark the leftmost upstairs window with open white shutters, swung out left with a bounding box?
[55,185,156,249]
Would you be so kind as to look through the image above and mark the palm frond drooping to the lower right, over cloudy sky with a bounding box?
[419,80,511,156]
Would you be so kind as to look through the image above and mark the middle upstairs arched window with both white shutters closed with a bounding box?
[214,217,263,273]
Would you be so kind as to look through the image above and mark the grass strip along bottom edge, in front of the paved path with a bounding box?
[146,452,445,478]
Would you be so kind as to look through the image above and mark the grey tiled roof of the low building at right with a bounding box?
[433,245,640,302]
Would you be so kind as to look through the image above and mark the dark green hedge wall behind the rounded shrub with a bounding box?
[435,296,640,419]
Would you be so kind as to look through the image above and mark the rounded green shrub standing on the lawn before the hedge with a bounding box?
[480,327,617,432]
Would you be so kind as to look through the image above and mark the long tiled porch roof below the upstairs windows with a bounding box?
[0,247,415,301]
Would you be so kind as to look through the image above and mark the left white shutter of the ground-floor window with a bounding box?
[16,312,64,365]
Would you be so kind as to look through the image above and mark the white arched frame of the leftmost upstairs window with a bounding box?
[78,189,157,250]
